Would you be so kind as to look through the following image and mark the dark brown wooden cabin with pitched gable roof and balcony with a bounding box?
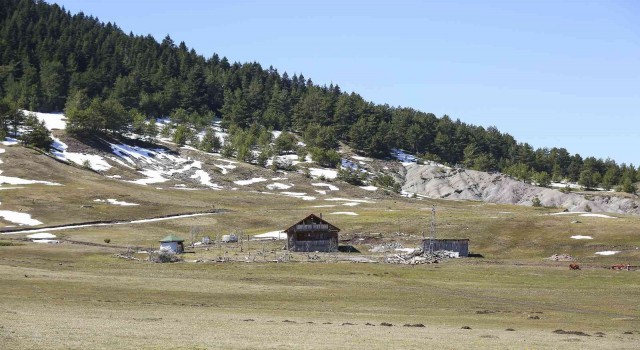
[284,214,340,252]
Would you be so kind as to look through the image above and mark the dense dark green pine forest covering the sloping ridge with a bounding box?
[0,0,637,192]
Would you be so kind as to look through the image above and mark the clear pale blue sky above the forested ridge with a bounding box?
[56,0,640,165]
